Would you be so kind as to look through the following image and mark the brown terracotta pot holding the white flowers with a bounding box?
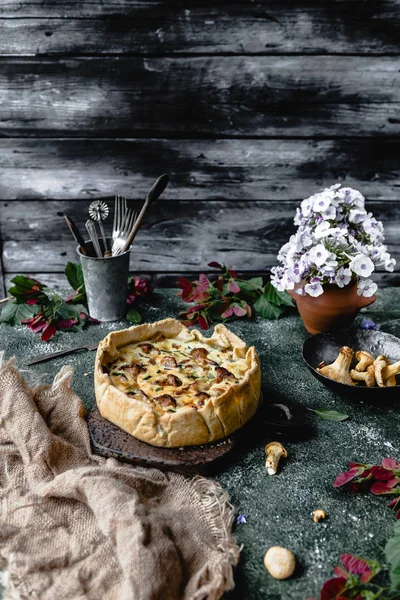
[288,282,376,333]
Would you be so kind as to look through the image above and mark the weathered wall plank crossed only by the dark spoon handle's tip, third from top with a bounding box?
[0,138,400,200]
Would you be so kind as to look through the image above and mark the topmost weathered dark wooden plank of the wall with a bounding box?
[0,0,400,54]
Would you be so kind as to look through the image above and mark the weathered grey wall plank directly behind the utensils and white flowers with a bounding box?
[0,200,400,273]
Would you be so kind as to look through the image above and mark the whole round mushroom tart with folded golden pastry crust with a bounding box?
[94,319,261,448]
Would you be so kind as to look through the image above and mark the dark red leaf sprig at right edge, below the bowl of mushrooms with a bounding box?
[333,458,400,519]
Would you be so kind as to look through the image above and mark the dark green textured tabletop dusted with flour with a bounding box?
[0,289,400,600]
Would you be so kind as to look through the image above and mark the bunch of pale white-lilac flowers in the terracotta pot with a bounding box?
[271,183,396,297]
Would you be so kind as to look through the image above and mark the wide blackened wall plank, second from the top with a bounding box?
[0,56,400,137]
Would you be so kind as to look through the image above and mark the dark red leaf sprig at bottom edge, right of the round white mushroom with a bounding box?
[308,554,382,600]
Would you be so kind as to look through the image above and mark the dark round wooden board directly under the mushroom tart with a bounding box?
[87,407,234,471]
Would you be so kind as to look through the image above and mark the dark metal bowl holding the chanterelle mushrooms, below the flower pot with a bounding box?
[303,328,400,401]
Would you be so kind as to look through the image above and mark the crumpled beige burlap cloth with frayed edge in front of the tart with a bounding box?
[0,358,239,600]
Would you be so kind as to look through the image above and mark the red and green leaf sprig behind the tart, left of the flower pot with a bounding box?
[178,262,293,329]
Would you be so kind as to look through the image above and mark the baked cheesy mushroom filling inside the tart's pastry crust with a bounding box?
[103,334,250,413]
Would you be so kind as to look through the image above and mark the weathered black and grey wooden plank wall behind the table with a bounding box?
[0,0,400,292]
